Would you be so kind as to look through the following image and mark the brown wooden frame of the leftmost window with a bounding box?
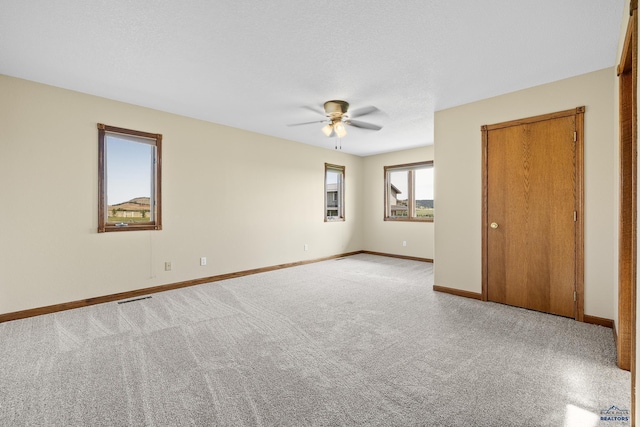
[98,123,162,233]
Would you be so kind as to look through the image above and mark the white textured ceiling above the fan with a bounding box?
[0,0,627,156]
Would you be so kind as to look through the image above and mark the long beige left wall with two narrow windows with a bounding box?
[0,76,370,313]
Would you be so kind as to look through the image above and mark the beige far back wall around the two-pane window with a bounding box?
[363,145,439,259]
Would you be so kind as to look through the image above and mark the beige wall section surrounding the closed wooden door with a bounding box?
[434,68,617,319]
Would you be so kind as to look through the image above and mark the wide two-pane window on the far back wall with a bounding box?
[384,161,433,221]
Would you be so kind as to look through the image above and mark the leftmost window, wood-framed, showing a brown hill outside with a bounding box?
[98,123,162,233]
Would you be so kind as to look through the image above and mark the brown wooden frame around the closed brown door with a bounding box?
[480,107,585,322]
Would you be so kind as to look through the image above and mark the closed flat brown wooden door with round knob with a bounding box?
[483,110,582,317]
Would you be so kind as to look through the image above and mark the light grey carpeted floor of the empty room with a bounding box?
[0,254,630,427]
